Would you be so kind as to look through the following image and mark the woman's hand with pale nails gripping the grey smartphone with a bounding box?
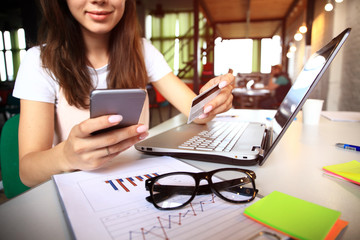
[63,115,148,171]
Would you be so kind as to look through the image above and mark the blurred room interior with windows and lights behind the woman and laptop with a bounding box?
[0,0,360,122]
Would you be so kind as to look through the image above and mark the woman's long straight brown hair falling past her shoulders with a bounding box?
[39,0,148,109]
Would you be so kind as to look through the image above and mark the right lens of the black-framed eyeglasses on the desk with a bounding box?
[211,170,254,202]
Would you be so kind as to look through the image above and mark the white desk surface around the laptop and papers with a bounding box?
[0,110,360,239]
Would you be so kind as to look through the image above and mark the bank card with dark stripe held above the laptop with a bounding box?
[187,84,221,124]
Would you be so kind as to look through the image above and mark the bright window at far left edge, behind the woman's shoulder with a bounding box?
[0,28,26,81]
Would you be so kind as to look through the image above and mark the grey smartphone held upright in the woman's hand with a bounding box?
[90,89,146,134]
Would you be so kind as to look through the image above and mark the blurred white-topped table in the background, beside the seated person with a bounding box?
[232,88,271,109]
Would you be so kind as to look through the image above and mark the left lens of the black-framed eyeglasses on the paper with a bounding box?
[153,174,196,209]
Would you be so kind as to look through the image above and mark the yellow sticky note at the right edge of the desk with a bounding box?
[323,160,360,184]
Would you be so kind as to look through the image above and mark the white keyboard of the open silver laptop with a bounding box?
[179,121,249,152]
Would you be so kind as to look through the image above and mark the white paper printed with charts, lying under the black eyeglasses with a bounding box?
[53,157,286,240]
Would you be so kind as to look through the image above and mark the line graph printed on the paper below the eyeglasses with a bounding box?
[101,192,269,240]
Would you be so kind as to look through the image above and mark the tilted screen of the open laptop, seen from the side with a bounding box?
[260,29,350,165]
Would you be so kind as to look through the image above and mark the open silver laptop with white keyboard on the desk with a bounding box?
[135,28,351,166]
